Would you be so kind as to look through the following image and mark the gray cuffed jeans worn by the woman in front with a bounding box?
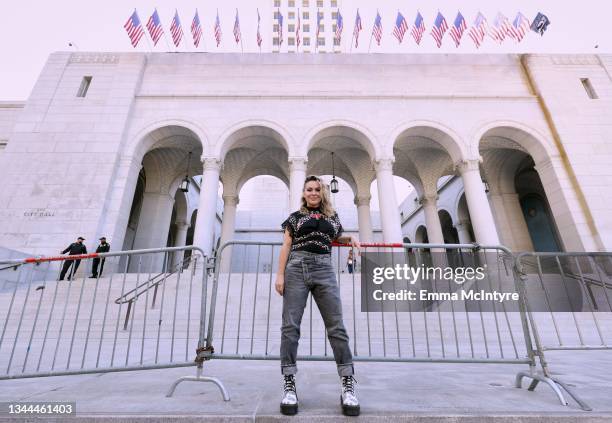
[280,251,353,376]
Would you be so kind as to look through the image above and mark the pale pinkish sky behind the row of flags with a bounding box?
[0,0,612,101]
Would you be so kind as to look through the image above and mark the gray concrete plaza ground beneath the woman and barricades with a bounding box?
[0,351,612,422]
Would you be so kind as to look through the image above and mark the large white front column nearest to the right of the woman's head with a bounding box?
[374,159,402,242]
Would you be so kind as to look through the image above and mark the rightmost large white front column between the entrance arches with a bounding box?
[457,160,500,245]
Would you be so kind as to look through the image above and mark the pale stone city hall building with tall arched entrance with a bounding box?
[0,52,612,255]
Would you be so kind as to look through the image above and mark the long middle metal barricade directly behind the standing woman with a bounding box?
[173,241,560,404]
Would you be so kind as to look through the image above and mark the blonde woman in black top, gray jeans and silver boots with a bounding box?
[275,176,360,416]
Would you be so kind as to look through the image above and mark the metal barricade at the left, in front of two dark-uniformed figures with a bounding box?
[0,246,227,396]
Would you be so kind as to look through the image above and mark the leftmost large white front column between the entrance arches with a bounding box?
[193,157,221,256]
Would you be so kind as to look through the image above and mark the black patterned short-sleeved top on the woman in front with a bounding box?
[281,208,343,254]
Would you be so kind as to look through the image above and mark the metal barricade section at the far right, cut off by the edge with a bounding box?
[516,252,612,411]
